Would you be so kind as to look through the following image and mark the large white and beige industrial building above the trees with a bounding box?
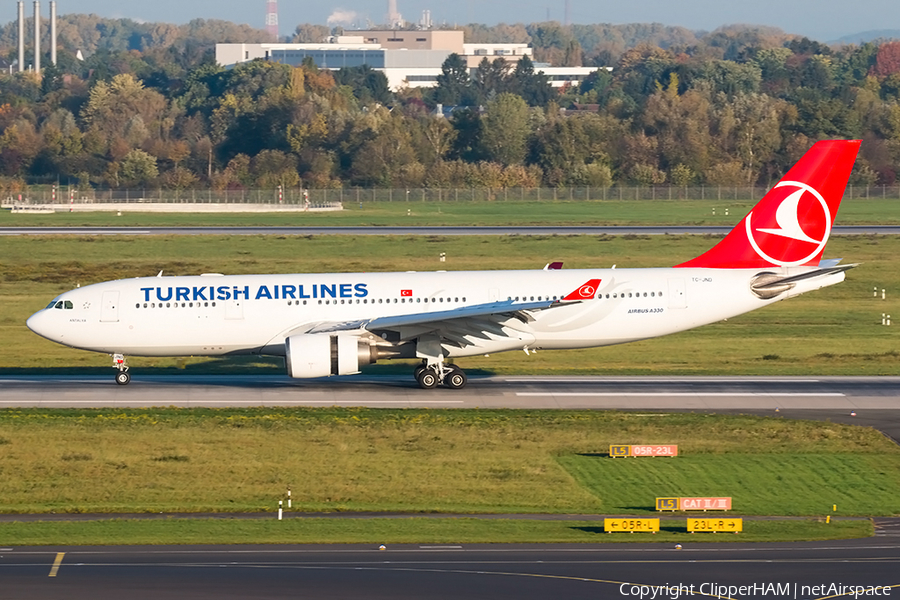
[216,29,597,90]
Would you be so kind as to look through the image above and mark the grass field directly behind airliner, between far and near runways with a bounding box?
[0,236,900,375]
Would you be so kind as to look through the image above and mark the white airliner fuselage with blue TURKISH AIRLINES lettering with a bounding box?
[28,268,844,357]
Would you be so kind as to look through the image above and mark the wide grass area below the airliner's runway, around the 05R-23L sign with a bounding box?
[0,408,900,516]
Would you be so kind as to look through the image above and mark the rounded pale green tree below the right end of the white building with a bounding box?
[482,93,531,165]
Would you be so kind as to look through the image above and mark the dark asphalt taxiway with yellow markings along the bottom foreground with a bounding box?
[0,536,900,600]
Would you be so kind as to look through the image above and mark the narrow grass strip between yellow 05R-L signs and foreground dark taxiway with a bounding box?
[0,517,873,548]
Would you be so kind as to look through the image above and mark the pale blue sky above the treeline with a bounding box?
[0,0,900,42]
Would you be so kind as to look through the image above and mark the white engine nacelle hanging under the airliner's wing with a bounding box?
[284,333,376,379]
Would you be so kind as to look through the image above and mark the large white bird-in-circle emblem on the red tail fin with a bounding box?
[746,181,831,267]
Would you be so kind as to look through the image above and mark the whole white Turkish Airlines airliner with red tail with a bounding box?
[27,140,861,389]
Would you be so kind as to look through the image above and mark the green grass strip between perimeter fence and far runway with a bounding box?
[0,198,900,227]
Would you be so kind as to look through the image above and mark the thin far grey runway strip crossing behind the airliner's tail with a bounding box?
[0,225,900,236]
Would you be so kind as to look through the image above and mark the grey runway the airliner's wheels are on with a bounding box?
[0,376,900,441]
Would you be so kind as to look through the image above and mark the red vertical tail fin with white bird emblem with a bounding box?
[677,140,862,269]
